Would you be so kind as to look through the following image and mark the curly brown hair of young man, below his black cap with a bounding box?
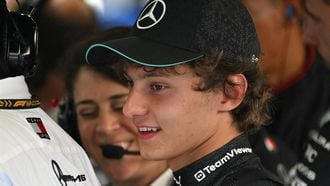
[114,52,272,133]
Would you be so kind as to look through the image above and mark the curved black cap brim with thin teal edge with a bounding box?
[85,36,203,67]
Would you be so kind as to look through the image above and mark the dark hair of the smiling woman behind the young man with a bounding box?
[58,27,131,145]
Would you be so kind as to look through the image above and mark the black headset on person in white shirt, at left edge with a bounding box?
[0,0,38,78]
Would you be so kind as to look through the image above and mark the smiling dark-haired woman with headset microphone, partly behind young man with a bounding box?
[58,27,173,186]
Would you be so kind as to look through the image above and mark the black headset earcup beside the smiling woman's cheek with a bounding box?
[57,96,81,145]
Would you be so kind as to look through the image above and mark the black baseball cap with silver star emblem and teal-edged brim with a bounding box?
[85,0,260,67]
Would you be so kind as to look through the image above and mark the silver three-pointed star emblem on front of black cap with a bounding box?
[136,0,166,29]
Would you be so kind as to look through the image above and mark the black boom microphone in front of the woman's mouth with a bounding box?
[101,145,140,159]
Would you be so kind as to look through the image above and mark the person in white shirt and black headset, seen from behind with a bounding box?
[0,0,100,186]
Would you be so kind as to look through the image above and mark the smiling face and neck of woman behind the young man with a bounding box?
[73,67,167,185]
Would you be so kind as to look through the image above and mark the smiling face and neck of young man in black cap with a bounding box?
[124,65,238,170]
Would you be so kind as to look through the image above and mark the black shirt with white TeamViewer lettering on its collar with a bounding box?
[173,134,283,186]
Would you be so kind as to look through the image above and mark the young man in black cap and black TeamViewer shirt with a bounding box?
[86,0,280,185]
